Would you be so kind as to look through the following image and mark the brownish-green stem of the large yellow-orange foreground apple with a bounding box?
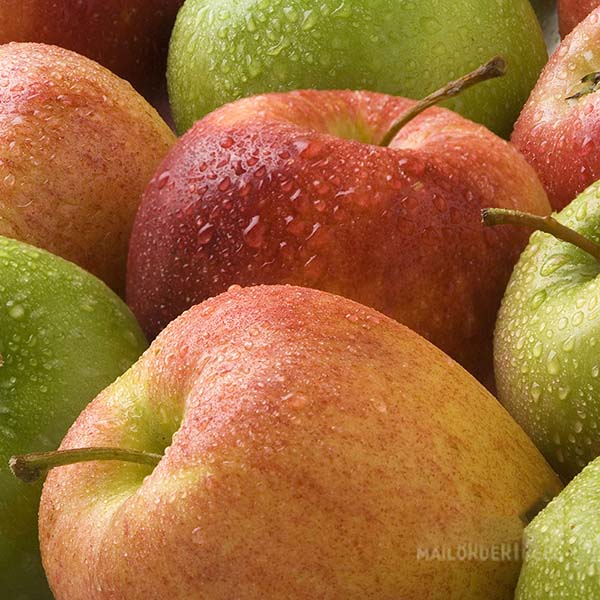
[8,448,162,483]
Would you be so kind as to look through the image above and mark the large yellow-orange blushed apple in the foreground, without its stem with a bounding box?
[40,286,560,600]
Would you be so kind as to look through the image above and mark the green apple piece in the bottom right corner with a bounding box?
[516,459,600,600]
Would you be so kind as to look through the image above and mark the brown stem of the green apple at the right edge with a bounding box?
[481,208,600,262]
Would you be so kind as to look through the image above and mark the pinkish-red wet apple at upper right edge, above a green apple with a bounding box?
[511,8,600,210]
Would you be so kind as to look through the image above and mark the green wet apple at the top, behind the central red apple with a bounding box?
[167,0,547,137]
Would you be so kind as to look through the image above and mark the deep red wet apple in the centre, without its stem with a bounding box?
[127,91,550,383]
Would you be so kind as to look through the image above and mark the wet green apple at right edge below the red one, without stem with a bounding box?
[494,183,600,480]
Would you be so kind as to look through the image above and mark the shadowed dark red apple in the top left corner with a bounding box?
[0,0,183,92]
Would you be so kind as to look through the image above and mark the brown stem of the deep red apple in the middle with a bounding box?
[381,56,506,146]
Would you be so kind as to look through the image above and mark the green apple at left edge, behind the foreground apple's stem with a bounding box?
[0,236,146,600]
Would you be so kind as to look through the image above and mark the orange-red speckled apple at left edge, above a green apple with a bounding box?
[0,43,175,292]
